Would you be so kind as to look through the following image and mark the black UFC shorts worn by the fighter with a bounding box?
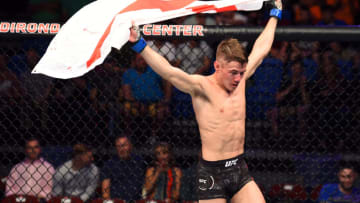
[197,154,253,200]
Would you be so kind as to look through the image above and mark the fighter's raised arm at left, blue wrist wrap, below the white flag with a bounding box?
[129,28,202,95]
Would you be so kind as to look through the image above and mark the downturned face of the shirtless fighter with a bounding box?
[215,59,246,92]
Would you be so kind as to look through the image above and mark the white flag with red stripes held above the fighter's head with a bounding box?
[32,0,267,79]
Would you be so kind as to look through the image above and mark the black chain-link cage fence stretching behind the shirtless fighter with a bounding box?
[0,25,360,202]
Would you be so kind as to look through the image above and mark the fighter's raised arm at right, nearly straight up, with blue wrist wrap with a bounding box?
[245,0,282,79]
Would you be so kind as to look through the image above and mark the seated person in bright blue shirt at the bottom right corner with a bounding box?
[318,166,360,203]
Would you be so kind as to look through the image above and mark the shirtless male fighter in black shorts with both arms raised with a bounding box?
[129,0,282,203]
